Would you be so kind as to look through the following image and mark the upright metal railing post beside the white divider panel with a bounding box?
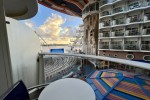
[38,54,45,84]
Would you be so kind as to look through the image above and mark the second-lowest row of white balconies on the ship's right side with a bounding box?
[99,29,150,38]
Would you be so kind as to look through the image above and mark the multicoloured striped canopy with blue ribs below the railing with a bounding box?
[86,70,150,100]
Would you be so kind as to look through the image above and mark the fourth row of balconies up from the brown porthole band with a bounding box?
[101,1,150,17]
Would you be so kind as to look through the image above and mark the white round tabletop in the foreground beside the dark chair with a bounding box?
[39,78,96,100]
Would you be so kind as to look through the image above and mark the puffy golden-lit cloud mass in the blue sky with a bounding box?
[24,13,81,44]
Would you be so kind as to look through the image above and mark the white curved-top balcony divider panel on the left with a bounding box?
[6,18,40,86]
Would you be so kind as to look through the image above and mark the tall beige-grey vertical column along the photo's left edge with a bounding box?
[0,0,12,95]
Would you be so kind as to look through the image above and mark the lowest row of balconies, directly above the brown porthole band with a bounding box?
[99,44,150,51]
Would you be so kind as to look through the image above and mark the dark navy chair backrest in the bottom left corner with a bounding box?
[0,80,29,100]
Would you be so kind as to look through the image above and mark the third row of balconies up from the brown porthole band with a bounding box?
[99,14,150,28]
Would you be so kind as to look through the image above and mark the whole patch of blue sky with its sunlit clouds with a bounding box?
[23,4,83,44]
